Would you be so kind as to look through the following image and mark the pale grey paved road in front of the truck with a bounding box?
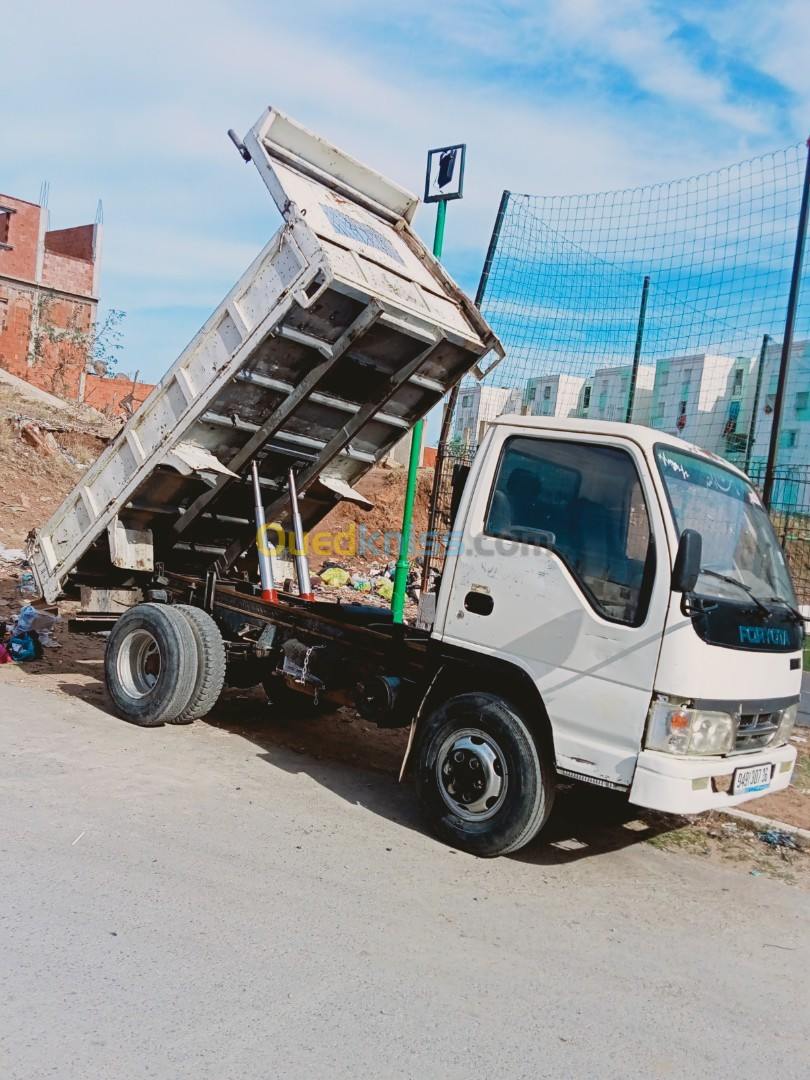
[0,685,810,1080]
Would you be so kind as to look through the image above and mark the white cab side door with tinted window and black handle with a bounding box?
[435,424,670,785]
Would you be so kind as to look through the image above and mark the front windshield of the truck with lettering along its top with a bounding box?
[656,446,796,607]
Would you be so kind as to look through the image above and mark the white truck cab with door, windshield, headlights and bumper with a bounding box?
[433,416,804,813]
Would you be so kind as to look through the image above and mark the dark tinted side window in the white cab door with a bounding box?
[484,436,652,625]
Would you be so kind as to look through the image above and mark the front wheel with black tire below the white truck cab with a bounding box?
[416,692,556,858]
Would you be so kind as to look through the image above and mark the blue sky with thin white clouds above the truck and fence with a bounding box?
[0,0,810,438]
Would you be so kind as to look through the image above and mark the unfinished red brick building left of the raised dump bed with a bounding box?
[0,194,152,415]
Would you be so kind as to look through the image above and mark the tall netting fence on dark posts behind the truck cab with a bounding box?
[425,144,810,600]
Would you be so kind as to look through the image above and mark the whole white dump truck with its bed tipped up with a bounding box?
[31,110,804,855]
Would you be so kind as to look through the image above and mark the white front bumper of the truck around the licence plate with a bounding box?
[630,743,796,813]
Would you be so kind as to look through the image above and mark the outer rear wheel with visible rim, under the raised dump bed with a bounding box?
[104,604,198,728]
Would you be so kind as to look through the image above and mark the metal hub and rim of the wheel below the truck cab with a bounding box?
[436,729,508,821]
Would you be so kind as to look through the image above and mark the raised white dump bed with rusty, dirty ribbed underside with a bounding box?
[31,109,502,600]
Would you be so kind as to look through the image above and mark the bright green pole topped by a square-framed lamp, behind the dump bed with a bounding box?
[391,144,467,623]
